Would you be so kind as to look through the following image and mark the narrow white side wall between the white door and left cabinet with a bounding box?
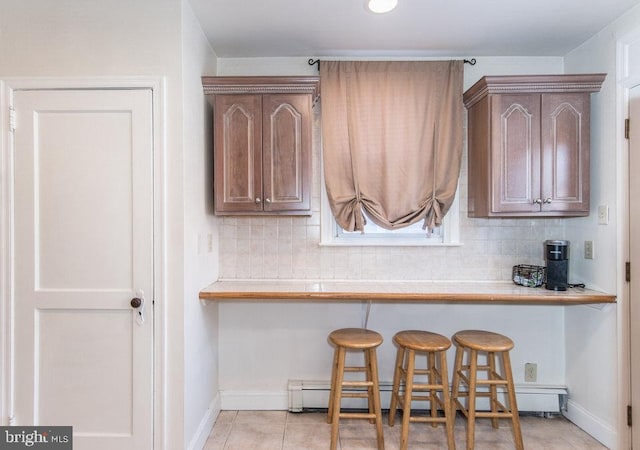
[182,1,220,449]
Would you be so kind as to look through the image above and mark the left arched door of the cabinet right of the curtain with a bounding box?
[492,94,540,213]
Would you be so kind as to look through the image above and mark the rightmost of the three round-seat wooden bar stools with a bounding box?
[451,330,524,450]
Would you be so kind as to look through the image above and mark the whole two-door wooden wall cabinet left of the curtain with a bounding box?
[202,77,319,215]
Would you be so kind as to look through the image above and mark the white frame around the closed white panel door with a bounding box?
[0,77,169,450]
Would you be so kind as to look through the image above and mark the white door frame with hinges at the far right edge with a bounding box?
[616,30,640,449]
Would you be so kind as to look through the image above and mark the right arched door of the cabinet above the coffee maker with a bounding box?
[541,94,589,213]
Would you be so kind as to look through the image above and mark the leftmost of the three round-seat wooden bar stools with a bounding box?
[327,328,384,450]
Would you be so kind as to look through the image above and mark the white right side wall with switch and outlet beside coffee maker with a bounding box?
[565,7,640,448]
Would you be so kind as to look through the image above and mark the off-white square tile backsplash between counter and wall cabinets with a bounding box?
[220,107,564,281]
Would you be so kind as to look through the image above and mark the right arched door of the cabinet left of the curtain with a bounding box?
[262,94,311,211]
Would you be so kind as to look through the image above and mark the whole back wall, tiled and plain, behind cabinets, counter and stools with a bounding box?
[218,58,576,414]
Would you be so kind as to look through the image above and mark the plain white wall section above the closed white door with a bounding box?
[0,0,180,78]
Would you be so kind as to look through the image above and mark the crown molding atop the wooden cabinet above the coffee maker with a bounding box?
[463,73,607,108]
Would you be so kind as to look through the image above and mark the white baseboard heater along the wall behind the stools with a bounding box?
[288,380,567,414]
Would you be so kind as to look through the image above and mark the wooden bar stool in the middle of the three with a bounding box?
[389,330,455,450]
